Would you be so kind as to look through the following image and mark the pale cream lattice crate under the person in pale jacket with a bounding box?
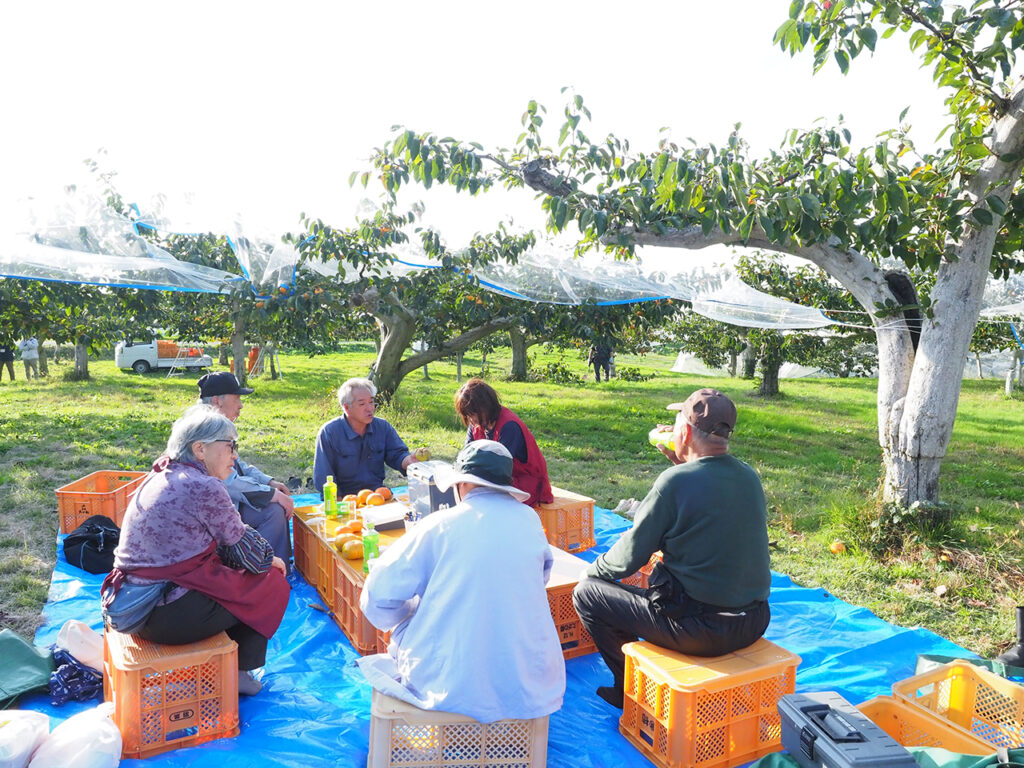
[367,690,548,768]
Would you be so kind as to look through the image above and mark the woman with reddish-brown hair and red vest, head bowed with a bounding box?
[455,379,554,507]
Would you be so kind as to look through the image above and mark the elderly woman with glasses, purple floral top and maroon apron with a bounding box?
[102,406,289,694]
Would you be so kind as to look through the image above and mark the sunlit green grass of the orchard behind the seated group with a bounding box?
[0,343,1024,654]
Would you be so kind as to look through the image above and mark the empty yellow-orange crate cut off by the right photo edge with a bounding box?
[893,662,1024,748]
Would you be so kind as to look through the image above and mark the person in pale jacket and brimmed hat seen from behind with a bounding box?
[358,440,565,723]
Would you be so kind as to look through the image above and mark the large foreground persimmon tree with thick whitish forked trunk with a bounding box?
[364,0,1024,512]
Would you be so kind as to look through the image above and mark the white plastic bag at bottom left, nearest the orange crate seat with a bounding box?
[29,701,121,768]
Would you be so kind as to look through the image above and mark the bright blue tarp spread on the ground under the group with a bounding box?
[18,499,973,768]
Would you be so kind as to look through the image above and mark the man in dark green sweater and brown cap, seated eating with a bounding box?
[572,389,771,709]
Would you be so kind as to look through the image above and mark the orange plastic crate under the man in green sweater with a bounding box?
[618,638,800,768]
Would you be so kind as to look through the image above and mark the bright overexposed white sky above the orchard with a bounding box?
[0,0,945,245]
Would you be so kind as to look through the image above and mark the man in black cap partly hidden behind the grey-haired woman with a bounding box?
[199,371,295,564]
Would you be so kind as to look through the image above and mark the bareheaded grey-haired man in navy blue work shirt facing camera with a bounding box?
[313,379,426,498]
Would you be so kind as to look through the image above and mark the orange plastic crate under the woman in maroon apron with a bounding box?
[103,630,239,758]
